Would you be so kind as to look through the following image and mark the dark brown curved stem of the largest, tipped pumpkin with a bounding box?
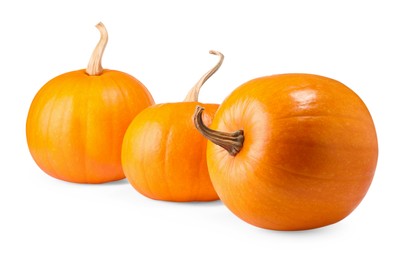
[194,106,244,156]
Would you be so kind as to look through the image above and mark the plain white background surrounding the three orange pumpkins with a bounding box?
[0,0,407,259]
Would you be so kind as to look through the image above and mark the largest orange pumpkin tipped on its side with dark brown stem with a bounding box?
[195,74,378,230]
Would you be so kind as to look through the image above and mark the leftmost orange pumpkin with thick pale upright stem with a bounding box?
[26,23,154,183]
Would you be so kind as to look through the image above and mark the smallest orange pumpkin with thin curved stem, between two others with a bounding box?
[122,51,223,202]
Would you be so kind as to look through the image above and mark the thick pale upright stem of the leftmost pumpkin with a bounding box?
[86,22,108,76]
